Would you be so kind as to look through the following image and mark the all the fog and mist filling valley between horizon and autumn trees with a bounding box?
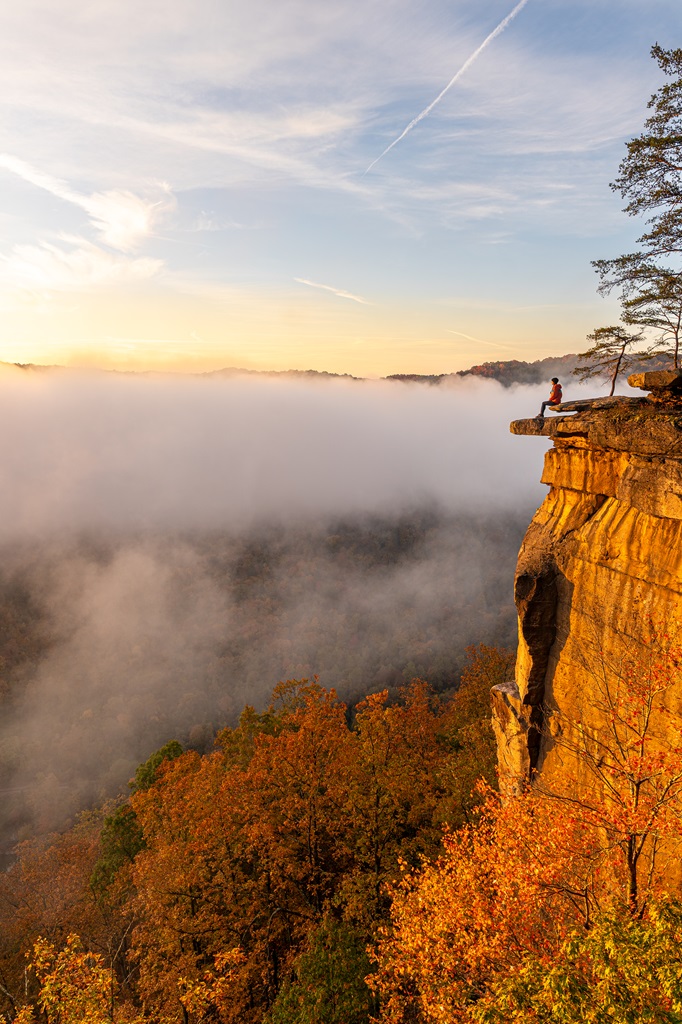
[0,371,557,850]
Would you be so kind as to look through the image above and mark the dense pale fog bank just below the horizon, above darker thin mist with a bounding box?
[0,372,546,539]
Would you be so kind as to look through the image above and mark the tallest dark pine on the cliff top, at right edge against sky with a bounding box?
[592,44,682,369]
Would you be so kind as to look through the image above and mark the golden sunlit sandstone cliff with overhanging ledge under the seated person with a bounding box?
[494,372,682,791]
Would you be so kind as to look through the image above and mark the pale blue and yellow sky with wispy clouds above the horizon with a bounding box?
[0,0,682,377]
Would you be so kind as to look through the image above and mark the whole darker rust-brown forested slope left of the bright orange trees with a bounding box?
[0,647,512,1024]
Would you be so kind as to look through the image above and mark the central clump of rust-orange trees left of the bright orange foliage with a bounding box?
[127,681,487,1024]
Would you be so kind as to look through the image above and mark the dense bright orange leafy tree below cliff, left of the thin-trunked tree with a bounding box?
[372,792,593,1024]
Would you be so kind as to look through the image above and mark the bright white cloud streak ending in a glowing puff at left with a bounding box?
[0,153,174,252]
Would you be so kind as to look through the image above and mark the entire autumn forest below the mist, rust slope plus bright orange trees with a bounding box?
[7,634,682,1024]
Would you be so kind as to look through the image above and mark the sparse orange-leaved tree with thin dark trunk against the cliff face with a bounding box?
[536,622,682,916]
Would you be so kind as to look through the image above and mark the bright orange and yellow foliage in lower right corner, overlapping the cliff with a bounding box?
[374,624,682,1024]
